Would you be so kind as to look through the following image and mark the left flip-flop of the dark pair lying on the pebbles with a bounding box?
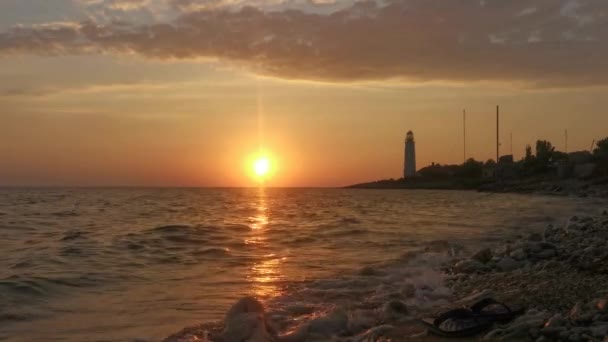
[421,309,494,337]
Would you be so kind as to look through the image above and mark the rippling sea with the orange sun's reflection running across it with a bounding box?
[0,188,607,341]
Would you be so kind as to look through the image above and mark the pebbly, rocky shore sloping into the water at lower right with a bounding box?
[164,206,608,342]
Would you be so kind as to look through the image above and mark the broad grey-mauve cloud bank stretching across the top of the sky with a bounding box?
[0,0,608,87]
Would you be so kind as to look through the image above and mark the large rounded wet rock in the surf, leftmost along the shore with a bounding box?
[222,297,276,342]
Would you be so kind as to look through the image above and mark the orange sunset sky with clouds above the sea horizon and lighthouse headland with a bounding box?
[0,0,608,187]
